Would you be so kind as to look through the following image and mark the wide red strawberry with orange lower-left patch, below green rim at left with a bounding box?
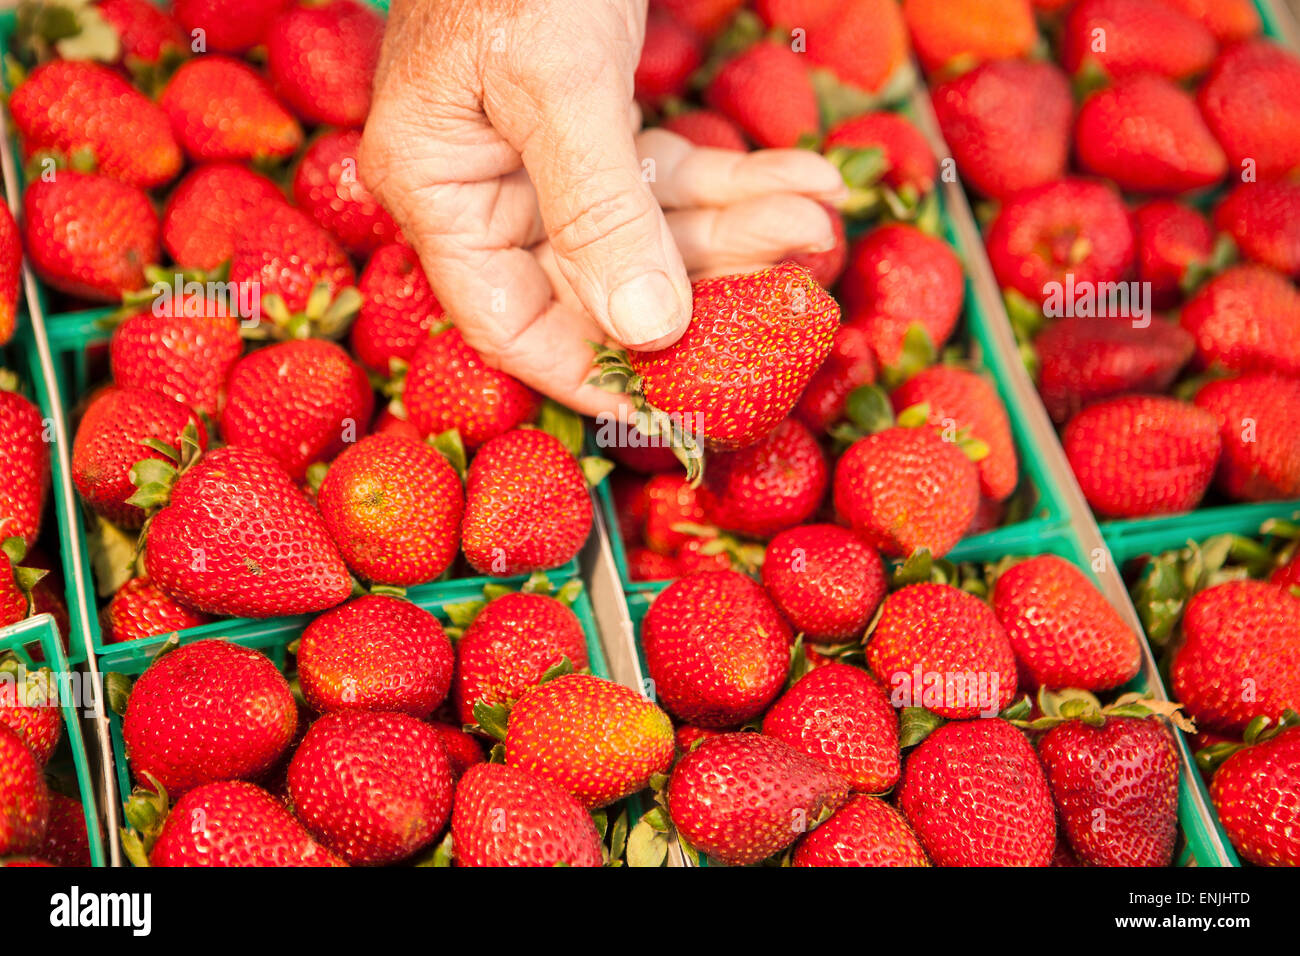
[298,594,455,718]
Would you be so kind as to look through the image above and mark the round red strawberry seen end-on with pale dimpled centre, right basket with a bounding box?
[985,178,1134,302]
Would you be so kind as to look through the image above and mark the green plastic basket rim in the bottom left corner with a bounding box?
[0,614,105,866]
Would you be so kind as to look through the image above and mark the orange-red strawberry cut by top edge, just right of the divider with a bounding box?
[902,0,1039,72]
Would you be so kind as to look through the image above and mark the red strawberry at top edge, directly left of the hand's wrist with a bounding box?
[267,0,384,126]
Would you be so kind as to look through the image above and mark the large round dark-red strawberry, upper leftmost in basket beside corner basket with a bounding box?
[122,640,298,795]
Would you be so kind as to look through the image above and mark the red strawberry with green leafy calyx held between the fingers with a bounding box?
[594,264,839,481]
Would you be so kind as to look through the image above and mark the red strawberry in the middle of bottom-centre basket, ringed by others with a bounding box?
[763,663,898,793]
